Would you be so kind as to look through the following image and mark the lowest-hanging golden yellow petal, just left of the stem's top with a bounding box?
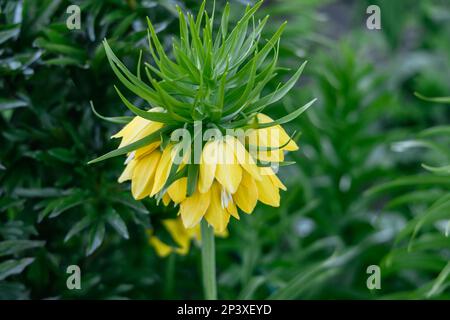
[180,190,211,228]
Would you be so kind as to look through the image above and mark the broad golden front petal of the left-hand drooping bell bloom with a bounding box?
[131,151,161,200]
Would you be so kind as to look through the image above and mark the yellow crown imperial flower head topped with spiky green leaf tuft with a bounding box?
[90,2,314,234]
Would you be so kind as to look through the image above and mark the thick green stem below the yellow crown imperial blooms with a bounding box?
[201,219,217,300]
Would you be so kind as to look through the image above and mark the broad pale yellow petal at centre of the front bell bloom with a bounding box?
[216,141,242,194]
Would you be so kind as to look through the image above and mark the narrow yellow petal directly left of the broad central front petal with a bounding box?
[198,141,218,193]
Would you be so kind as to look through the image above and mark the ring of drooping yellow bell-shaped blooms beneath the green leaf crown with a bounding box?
[113,114,298,232]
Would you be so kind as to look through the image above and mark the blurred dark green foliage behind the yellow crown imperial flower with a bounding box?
[0,0,450,299]
